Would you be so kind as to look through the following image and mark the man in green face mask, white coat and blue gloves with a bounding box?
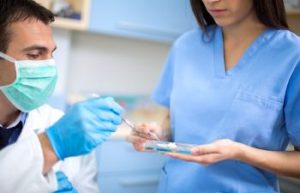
[0,0,123,193]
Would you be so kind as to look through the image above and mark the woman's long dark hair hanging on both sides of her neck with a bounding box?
[191,0,289,31]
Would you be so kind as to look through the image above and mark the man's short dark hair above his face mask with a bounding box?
[0,0,54,52]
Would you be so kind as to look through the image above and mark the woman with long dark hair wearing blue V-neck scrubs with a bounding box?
[128,0,300,193]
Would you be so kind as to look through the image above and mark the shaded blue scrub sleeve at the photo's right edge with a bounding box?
[284,61,300,147]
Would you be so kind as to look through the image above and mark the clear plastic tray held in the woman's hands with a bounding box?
[144,141,194,155]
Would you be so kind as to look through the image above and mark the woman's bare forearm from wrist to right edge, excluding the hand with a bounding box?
[238,144,300,178]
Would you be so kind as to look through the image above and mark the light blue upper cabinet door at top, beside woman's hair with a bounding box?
[89,0,195,41]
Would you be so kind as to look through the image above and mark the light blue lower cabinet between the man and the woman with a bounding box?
[96,139,166,193]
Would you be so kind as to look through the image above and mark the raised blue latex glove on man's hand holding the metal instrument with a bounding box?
[46,97,123,160]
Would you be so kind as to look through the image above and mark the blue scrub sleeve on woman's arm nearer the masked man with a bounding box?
[151,47,174,108]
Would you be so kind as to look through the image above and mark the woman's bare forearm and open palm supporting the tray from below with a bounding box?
[166,139,300,177]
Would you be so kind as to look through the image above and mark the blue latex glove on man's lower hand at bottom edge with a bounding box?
[54,171,77,193]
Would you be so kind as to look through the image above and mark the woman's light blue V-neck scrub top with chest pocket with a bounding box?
[153,26,300,193]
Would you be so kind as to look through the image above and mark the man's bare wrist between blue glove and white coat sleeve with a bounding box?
[38,133,58,175]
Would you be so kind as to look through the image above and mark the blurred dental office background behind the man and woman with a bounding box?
[37,0,300,193]
